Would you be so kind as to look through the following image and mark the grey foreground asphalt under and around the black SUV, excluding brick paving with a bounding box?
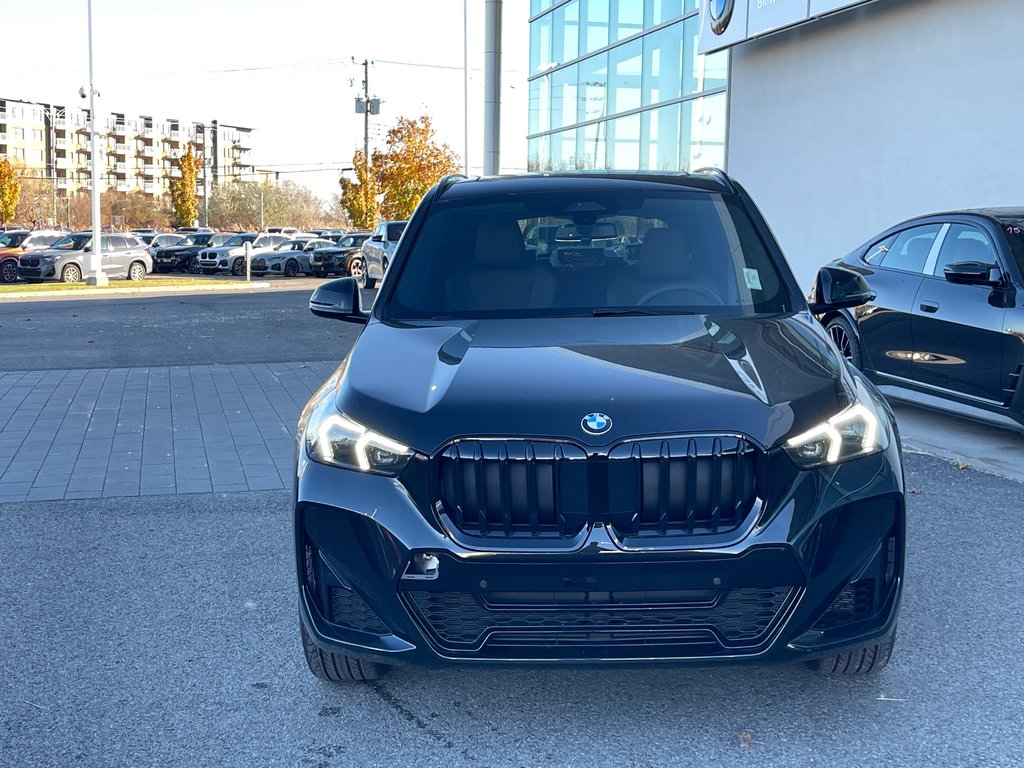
[0,457,1024,768]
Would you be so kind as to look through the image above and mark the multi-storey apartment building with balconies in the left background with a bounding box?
[0,97,254,197]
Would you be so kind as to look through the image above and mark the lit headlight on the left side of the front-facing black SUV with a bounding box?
[305,397,413,476]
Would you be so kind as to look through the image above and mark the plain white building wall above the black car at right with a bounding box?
[728,0,1024,287]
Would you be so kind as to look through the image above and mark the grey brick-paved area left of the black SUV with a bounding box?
[0,362,334,502]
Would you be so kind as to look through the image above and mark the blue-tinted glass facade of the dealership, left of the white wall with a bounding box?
[527,0,728,171]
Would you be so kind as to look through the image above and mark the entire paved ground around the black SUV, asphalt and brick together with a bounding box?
[0,290,1024,766]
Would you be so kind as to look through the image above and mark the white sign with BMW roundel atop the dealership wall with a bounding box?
[699,0,871,53]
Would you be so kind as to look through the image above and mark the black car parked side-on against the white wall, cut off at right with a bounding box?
[819,208,1024,427]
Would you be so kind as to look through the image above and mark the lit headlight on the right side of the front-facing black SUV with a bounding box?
[785,382,889,469]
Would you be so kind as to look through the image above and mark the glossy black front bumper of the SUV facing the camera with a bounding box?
[295,446,904,666]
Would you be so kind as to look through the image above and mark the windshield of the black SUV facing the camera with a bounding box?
[382,189,794,319]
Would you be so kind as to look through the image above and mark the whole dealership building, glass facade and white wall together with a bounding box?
[527,0,1024,285]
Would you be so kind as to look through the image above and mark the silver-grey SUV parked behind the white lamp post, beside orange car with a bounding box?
[17,231,153,283]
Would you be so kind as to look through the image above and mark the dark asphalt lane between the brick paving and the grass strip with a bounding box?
[0,288,360,371]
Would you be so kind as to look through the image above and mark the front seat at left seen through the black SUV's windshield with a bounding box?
[445,218,555,310]
